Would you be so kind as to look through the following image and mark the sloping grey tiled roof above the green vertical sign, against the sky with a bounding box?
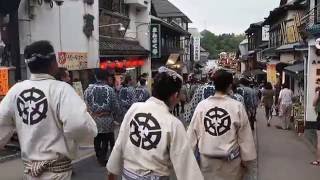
[152,0,192,23]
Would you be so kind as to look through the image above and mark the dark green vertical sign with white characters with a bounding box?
[150,24,161,58]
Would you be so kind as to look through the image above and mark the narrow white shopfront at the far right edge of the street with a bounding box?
[299,0,320,129]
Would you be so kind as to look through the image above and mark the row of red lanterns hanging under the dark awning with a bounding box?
[100,59,144,69]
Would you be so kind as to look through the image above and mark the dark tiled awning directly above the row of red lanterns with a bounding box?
[99,37,149,57]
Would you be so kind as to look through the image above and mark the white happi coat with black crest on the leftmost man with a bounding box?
[0,74,97,161]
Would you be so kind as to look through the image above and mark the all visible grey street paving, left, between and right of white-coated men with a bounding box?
[0,109,320,180]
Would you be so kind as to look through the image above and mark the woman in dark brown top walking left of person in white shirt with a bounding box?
[261,82,275,126]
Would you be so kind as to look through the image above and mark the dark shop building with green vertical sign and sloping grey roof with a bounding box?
[150,0,192,74]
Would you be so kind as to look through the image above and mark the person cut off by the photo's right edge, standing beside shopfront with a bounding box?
[311,89,320,166]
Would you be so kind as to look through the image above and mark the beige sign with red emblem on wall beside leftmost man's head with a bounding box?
[58,52,88,71]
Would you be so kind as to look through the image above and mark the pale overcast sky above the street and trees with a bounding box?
[169,0,280,34]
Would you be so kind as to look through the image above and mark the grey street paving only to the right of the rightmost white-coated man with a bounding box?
[257,109,320,180]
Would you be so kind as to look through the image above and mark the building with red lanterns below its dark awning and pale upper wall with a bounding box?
[99,0,151,83]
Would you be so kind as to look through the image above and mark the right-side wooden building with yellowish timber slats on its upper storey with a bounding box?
[261,0,308,96]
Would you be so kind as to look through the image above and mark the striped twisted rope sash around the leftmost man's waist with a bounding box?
[23,158,72,177]
